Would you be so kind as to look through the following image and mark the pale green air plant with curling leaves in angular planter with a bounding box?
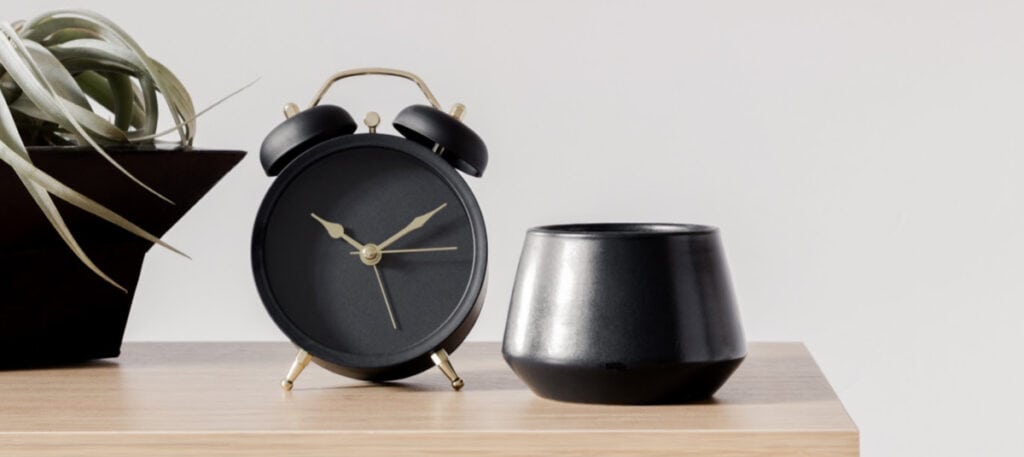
[0,10,221,290]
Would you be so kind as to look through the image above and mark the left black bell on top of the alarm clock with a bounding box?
[259,105,357,176]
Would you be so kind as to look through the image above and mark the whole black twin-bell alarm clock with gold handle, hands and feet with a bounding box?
[252,68,487,390]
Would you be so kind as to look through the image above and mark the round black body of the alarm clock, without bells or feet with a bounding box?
[252,133,487,381]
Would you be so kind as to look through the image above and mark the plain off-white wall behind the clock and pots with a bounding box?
[2,0,1024,456]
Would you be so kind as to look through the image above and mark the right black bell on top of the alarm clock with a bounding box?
[392,105,487,177]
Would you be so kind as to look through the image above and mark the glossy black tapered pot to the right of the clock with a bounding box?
[503,223,746,404]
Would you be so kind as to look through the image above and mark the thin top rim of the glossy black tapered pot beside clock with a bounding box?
[526,222,718,238]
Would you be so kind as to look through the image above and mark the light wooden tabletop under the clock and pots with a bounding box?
[0,343,859,457]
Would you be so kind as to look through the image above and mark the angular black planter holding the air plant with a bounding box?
[0,148,245,368]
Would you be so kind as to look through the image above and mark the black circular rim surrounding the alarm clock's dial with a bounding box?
[252,133,487,381]
